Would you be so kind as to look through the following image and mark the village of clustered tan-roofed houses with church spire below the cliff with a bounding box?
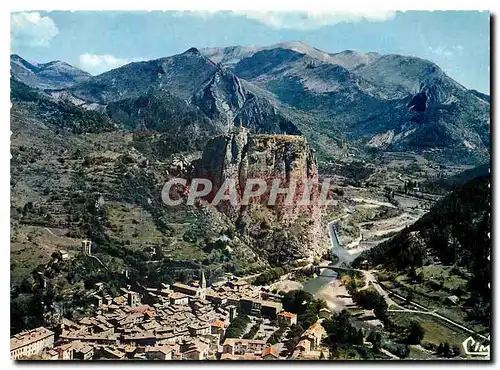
[10,251,330,360]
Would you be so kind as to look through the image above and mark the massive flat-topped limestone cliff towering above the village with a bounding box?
[196,127,324,264]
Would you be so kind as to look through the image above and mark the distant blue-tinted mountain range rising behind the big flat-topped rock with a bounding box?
[11,42,490,163]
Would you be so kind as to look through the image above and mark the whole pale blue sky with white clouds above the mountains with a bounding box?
[11,11,490,94]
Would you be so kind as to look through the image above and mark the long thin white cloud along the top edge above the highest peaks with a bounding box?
[175,10,396,30]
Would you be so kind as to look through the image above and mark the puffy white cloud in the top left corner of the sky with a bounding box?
[10,12,59,46]
